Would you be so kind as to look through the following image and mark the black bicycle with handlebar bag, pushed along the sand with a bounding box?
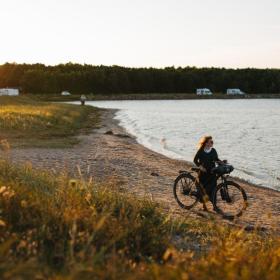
[173,162,248,219]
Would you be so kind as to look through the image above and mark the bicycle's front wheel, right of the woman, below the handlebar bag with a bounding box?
[213,181,247,218]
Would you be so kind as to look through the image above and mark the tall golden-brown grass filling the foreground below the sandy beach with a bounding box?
[0,161,280,279]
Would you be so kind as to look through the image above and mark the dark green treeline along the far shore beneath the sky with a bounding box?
[0,63,280,94]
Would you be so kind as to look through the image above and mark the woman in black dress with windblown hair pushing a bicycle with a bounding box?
[194,136,221,201]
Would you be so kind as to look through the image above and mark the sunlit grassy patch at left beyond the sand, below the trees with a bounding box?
[0,96,99,147]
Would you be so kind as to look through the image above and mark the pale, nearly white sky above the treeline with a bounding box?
[0,0,280,68]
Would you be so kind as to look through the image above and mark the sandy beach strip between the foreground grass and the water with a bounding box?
[0,110,280,231]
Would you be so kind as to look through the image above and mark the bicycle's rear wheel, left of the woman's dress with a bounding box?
[173,173,199,210]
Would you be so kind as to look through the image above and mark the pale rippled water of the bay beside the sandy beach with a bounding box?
[83,99,280,190]
